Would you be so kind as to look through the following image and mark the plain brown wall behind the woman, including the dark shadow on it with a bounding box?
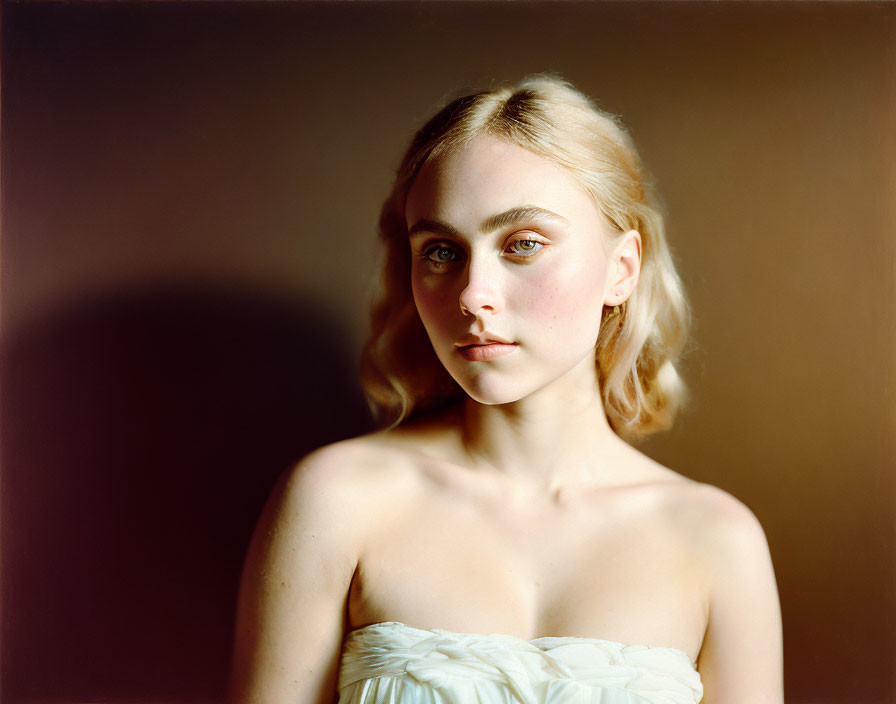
[2,2,896,703]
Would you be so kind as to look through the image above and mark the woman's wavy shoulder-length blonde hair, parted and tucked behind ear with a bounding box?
[361,75,689,440]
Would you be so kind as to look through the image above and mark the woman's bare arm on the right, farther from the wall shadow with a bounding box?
[697,487,784,704]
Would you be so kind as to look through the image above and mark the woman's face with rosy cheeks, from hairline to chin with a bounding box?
[406,136,615,404]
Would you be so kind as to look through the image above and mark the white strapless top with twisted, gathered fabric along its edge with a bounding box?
[339,621,703,704]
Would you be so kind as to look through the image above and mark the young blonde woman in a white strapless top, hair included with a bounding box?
[232,77,783,704]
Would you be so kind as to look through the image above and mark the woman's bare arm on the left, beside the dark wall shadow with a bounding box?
[229,450,359,704]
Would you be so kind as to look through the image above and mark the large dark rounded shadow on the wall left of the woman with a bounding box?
[2,290,370,703]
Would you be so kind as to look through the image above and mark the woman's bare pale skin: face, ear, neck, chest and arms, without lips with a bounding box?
[231,137,783,704]
